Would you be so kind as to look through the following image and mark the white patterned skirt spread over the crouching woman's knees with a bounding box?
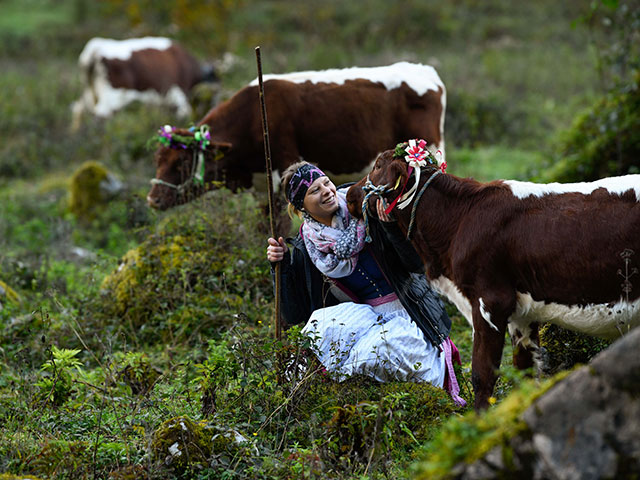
[302,300,446,387]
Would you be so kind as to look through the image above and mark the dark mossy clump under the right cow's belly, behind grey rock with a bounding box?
[539,323,611,374]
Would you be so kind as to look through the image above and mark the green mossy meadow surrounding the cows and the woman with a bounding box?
[0,0,635,479]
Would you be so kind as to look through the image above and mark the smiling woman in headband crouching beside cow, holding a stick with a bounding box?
[267,162,464,404]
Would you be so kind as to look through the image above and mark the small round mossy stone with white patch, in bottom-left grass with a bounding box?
[151,417,213,474]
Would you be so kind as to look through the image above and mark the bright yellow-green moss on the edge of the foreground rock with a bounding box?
[414,372,568,480]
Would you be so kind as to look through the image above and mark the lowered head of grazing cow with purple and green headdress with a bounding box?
[147,126,231,210]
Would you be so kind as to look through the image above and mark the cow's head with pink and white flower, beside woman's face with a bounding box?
[347,140,446,218]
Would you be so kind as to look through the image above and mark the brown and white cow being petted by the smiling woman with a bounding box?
[347,143,640,410]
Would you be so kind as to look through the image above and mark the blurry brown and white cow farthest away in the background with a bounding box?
[71,37,217,129]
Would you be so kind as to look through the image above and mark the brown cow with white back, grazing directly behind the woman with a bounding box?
[147,62,446,209]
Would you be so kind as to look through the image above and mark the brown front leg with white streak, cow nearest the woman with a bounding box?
[471,292,515,410]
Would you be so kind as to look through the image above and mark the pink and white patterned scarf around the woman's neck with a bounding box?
[302,188,366,278]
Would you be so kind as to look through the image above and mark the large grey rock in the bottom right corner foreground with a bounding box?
[417,328,640,480]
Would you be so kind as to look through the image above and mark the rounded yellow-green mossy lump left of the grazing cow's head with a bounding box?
[69,161,108,221]
